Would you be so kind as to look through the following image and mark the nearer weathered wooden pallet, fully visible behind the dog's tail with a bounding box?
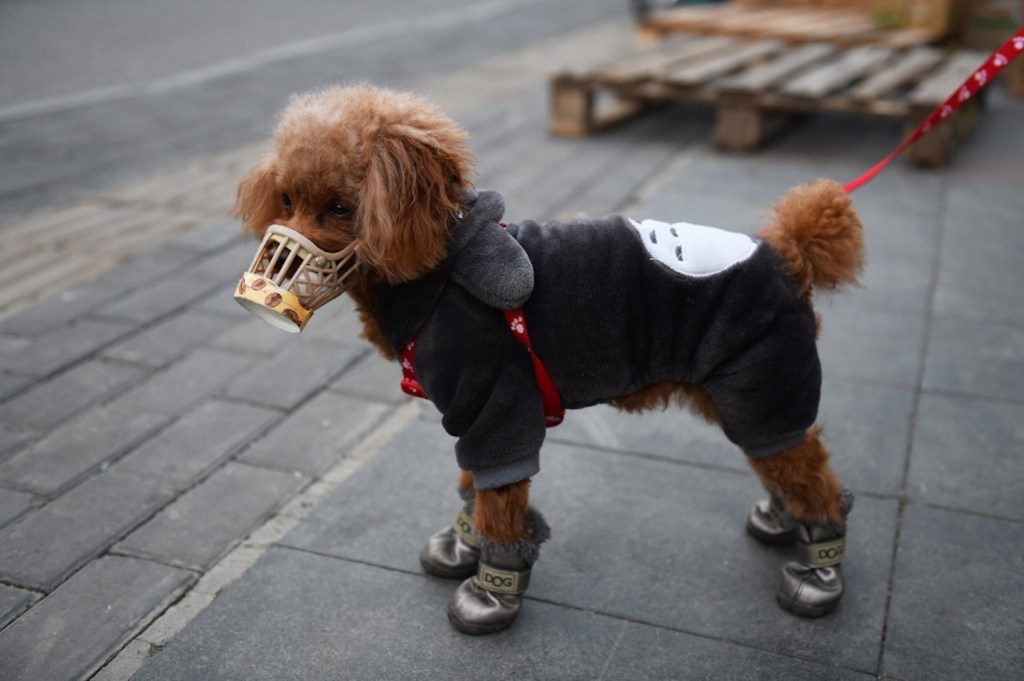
[550,36,986,165]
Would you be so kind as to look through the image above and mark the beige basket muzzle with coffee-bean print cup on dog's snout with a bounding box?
[234,224,359,333]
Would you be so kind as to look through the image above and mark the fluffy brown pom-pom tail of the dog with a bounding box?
[761,179,864,297]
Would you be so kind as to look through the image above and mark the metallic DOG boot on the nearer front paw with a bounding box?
[447,509,551,636]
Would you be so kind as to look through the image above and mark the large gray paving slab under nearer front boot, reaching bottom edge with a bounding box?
[133,549,623,681]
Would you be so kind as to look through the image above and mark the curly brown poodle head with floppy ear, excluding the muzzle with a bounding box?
[234,86,473,284]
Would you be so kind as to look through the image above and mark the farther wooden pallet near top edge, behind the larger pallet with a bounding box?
[640,2,946,47]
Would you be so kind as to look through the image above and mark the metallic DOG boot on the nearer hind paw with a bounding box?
[776,491,853,618]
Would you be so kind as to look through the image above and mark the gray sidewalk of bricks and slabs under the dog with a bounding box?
[0,14,1024,681]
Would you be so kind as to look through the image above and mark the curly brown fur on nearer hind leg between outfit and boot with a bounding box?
[750,428,845,526]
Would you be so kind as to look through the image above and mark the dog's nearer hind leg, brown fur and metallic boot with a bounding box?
[748,429,853,618]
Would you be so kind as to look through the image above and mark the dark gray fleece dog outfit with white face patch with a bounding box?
[379,191,821,490]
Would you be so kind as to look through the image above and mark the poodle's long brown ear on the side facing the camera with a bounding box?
[356,124,472,284]
